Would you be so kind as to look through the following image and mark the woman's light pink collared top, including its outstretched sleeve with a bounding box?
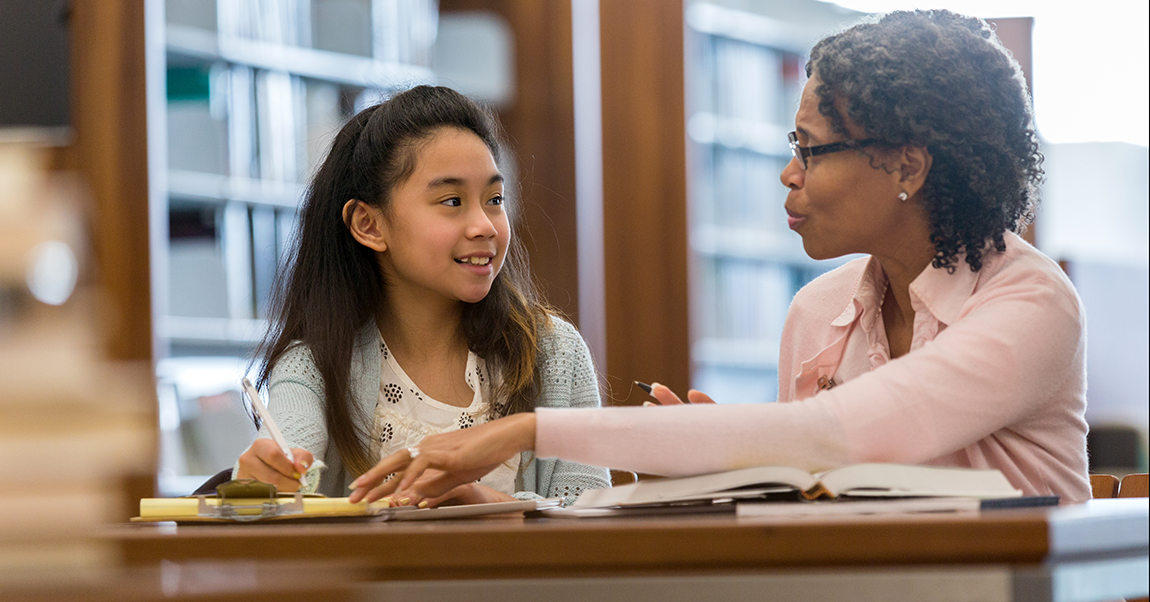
[536,234,1090,502]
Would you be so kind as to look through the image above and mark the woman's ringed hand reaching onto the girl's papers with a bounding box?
[350,413,535,503]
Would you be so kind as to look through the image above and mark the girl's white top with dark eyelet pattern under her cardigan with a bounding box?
[371,336,520,495]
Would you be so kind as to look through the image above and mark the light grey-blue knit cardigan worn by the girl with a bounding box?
[237,318,611,505]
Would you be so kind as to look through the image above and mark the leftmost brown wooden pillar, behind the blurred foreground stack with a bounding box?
[67,0,152,360]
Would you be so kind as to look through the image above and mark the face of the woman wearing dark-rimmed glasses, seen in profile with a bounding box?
[780,77,914,259]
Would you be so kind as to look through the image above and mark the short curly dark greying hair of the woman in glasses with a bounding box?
[806,10,1043,272]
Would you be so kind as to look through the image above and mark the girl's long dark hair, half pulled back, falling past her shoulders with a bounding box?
[256,86,550,474]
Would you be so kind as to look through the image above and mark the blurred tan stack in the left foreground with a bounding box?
[0,143,155,586]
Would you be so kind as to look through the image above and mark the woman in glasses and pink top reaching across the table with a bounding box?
[353,10,1090,502]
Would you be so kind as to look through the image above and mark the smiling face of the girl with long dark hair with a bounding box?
[381,128,511,303]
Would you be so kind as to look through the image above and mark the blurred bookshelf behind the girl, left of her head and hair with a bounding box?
[147,0,438,495]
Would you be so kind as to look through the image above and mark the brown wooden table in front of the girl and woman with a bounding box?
[107,500,1150,602]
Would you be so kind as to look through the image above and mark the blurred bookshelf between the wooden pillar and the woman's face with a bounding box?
[684,2,852,403]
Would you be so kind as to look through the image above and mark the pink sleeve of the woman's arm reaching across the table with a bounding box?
[536,261,1084,475]
